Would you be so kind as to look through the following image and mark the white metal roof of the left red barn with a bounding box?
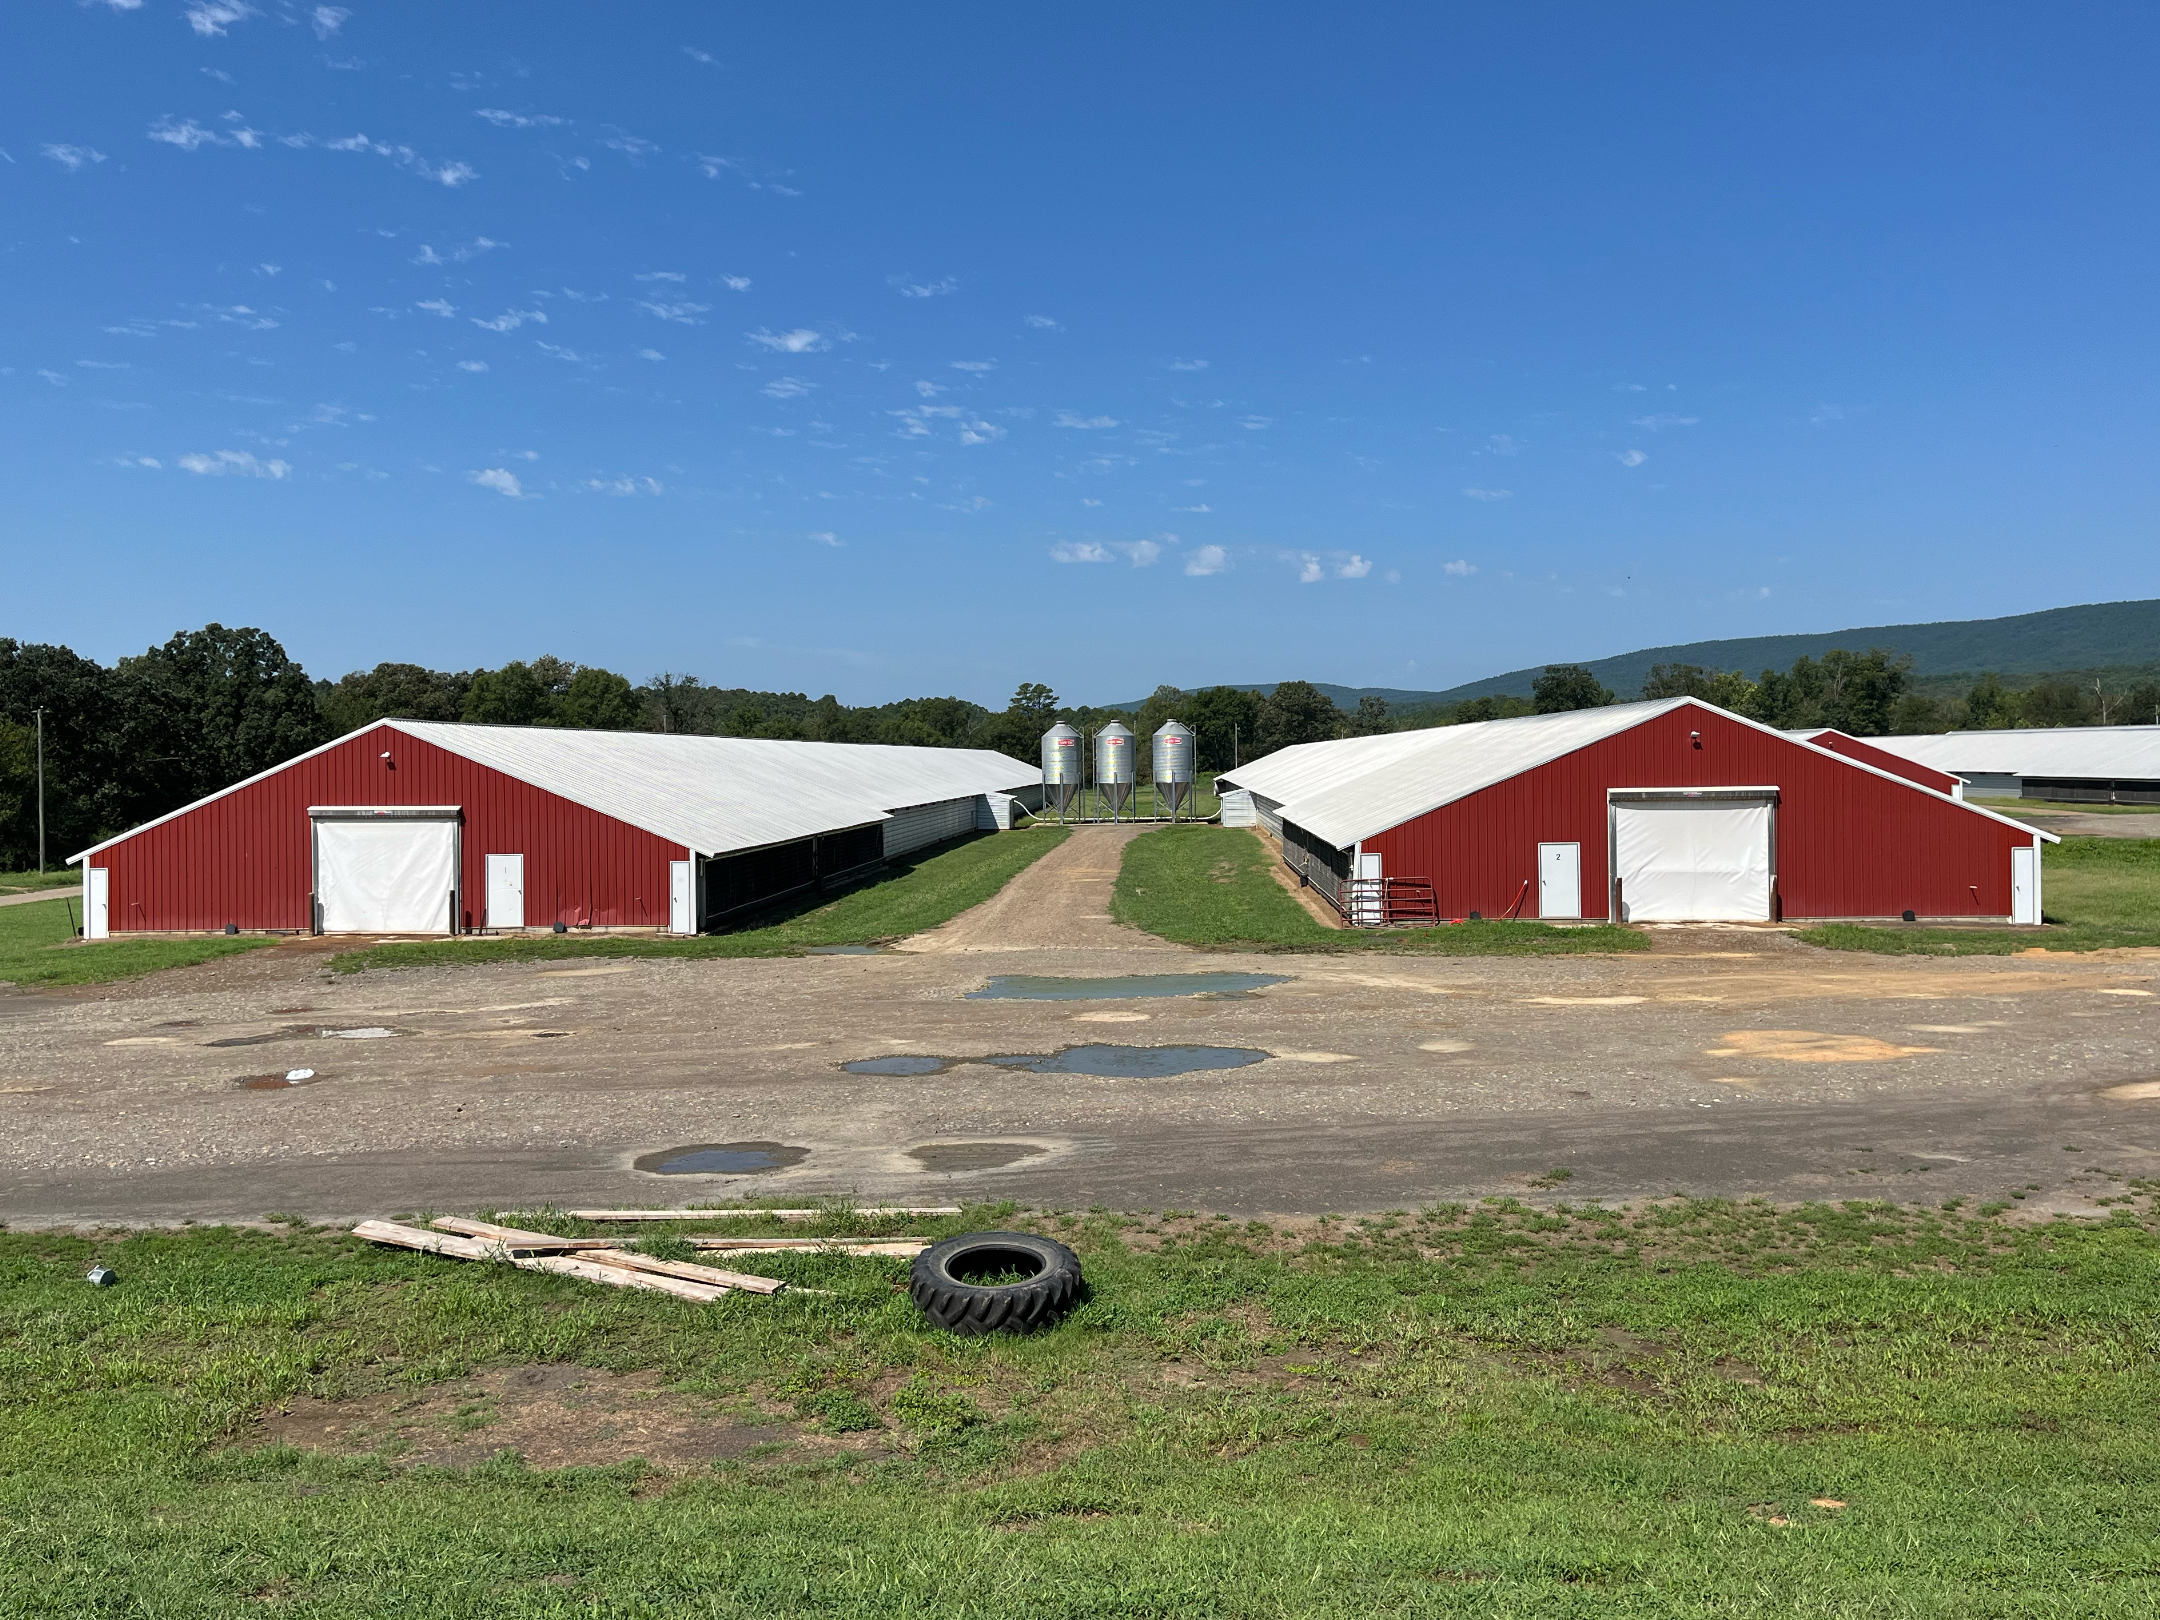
[69,719,1041,864]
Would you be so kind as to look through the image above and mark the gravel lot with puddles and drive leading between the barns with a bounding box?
[0,829,2160,1225]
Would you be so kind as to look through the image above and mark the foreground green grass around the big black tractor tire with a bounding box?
[0,1200,2160,1620]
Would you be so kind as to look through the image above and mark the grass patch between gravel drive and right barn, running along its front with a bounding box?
[1110,827,1650,957]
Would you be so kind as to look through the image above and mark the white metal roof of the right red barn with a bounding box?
[1216,698,2054,849]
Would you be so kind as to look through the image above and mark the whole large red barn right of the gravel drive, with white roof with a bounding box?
[1220,698,2056,922]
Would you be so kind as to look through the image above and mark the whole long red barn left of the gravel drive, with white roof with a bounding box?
[73,719,1039,937]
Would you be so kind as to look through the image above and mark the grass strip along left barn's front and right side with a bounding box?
[330,827,1071,972]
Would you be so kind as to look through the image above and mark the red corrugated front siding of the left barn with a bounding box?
[86,726,689,933]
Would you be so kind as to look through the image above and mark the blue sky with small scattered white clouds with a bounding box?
[0,0,2160,702]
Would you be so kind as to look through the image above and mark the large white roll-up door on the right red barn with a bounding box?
[1614,799,1771,922]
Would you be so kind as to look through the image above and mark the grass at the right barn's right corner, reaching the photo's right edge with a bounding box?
[1799,838,2160,957]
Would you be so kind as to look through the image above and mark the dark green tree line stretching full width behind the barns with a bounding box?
[0,624,2160,870]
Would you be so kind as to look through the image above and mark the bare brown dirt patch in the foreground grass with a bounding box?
[246,1365,797,1471]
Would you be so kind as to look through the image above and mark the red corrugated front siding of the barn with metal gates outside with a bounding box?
[1361,708,2033,918]
